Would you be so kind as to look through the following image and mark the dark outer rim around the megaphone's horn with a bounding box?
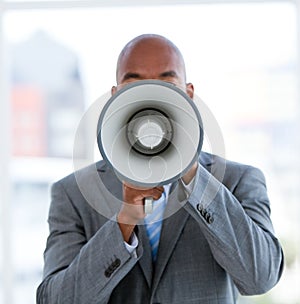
[97,79,204,187]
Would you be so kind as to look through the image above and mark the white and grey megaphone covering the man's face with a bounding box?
[97,80,203,213]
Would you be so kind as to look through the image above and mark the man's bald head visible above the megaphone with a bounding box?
[116,34,186,86]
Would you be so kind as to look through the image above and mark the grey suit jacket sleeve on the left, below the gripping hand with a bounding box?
[37,183,142,304]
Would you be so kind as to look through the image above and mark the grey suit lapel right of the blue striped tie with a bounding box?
[152,187,189,293]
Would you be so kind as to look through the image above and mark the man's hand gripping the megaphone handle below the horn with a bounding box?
[117,182,164,242]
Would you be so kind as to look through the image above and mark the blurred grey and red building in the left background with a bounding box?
[11,31,85,158]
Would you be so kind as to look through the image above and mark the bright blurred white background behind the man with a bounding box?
[0,0,300,304]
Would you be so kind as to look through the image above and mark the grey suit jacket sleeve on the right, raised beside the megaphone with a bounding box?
[185,165,283,295]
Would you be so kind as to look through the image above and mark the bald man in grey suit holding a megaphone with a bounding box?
[37,35,283,304]
